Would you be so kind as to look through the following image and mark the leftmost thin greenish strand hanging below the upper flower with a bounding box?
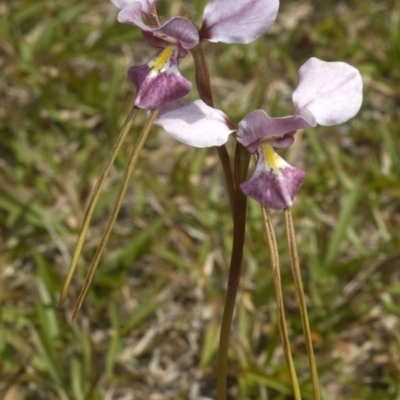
[59,106,139,307]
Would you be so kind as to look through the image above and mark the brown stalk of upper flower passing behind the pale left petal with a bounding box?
[190,42,235,213]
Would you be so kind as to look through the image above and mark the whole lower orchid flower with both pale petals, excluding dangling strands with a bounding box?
[156,58,362,205]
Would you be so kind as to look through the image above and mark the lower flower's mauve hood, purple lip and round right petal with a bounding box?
[237,58,362,210]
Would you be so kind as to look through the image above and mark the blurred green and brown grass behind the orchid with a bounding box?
[0,0,400,400]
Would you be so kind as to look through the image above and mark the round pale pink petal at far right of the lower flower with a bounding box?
[293,58,363,125]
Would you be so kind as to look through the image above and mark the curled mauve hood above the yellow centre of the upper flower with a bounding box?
[118,1,199,50]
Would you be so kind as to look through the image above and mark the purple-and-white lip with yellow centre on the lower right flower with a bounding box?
[240,144,305,210]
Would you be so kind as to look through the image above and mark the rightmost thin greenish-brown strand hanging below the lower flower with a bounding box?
[284,208,321,400]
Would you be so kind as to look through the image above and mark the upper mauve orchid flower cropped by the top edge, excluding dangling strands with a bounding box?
[111,0,279,110]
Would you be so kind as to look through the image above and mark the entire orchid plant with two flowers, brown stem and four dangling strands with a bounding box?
[60,0,362,400]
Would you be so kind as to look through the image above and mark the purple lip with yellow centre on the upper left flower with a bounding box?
[128,46,192,110]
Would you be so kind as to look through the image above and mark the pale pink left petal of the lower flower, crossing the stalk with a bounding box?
[155,99,234,147]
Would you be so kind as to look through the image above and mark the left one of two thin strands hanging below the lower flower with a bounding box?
[262,207,301,400]
